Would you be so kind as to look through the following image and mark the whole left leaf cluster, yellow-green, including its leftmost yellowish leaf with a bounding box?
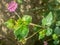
[5,15,32,40]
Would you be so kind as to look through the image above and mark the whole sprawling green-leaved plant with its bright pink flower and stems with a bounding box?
[5,0,60,45]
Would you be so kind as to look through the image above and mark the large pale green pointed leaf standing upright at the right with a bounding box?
[42,12,53,26]
